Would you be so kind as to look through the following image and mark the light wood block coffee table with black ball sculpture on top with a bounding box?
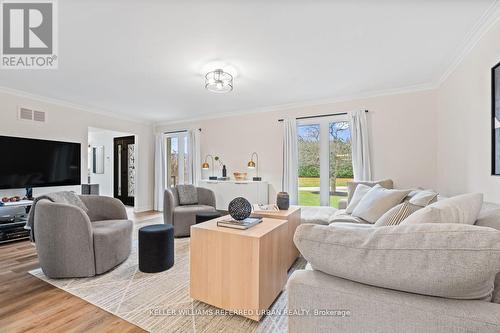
[190,217,293,320]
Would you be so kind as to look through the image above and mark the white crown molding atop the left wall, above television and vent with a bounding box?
[0,86,154,125]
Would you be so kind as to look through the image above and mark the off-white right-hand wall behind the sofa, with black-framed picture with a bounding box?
[437,16,500,202]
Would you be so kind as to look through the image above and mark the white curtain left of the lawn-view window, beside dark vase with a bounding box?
[282,118,299,205]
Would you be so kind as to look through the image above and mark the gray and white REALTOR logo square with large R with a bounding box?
[1,0,57,69]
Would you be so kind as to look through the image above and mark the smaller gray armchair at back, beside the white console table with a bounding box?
[163,187,216,237]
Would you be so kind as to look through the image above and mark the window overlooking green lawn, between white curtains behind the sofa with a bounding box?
[297,116,353,207]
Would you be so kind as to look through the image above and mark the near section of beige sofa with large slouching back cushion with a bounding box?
[287,182,500,333]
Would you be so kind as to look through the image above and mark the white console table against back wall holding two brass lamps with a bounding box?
[200,180,269,210]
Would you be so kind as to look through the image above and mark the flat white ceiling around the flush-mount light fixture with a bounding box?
[0,0,495,121]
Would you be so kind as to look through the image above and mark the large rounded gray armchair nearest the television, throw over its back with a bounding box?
[34,195,133,278]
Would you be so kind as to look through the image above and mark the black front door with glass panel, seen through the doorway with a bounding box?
[113,136,135,206]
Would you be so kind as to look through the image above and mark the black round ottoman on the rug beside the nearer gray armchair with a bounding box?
[139,224,174,273]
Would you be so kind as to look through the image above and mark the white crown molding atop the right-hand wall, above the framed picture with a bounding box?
[436,0,500,87]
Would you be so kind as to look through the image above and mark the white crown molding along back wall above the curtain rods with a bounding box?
[155,83,437,127]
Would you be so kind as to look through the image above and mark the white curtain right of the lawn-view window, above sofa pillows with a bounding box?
[349,110,372,181]
